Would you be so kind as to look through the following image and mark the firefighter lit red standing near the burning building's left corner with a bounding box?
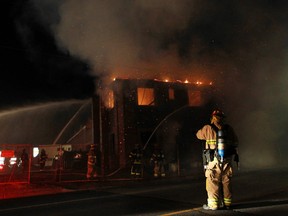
[86,144,100,180]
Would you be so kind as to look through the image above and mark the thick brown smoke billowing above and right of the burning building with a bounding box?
[29,0,288,167]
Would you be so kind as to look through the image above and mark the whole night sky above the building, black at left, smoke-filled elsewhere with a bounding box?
[0,0,288,167]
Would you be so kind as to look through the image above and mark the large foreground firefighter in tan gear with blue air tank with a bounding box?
[196,110,239,210]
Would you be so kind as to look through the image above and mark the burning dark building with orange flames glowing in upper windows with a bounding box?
[87,79,214,176]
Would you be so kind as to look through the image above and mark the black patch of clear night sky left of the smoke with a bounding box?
[0,0,94,108]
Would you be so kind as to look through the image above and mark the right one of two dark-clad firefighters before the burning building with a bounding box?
[150,145,166,178]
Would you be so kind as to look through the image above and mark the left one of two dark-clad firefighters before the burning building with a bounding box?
[129,144,143,178]
